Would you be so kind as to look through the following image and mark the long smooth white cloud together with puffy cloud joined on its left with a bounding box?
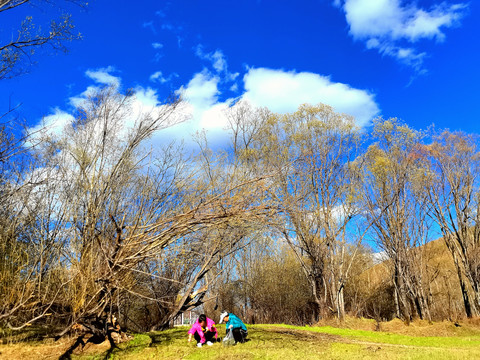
[166,68,379,144]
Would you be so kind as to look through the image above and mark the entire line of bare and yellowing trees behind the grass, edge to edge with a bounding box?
[0,88,480,344]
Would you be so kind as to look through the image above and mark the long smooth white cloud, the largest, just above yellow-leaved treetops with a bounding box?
[243,68,379,125]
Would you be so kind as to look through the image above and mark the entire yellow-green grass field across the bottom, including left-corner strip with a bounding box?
[0,323,480,360]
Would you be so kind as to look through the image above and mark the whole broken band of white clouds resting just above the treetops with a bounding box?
[32,64,379,150]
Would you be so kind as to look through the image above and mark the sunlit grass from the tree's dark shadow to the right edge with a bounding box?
[77,325,480,360]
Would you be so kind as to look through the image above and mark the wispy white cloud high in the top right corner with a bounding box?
[334,0,467,70]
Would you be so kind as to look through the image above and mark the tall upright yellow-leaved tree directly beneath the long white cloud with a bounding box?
[258,105,361,319]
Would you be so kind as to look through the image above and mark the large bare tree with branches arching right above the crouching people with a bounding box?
[12,87,274,350]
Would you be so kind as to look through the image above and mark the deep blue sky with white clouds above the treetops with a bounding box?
[0,0,480,145]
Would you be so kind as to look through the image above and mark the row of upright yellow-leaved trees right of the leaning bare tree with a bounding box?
[208,105,480,323]
